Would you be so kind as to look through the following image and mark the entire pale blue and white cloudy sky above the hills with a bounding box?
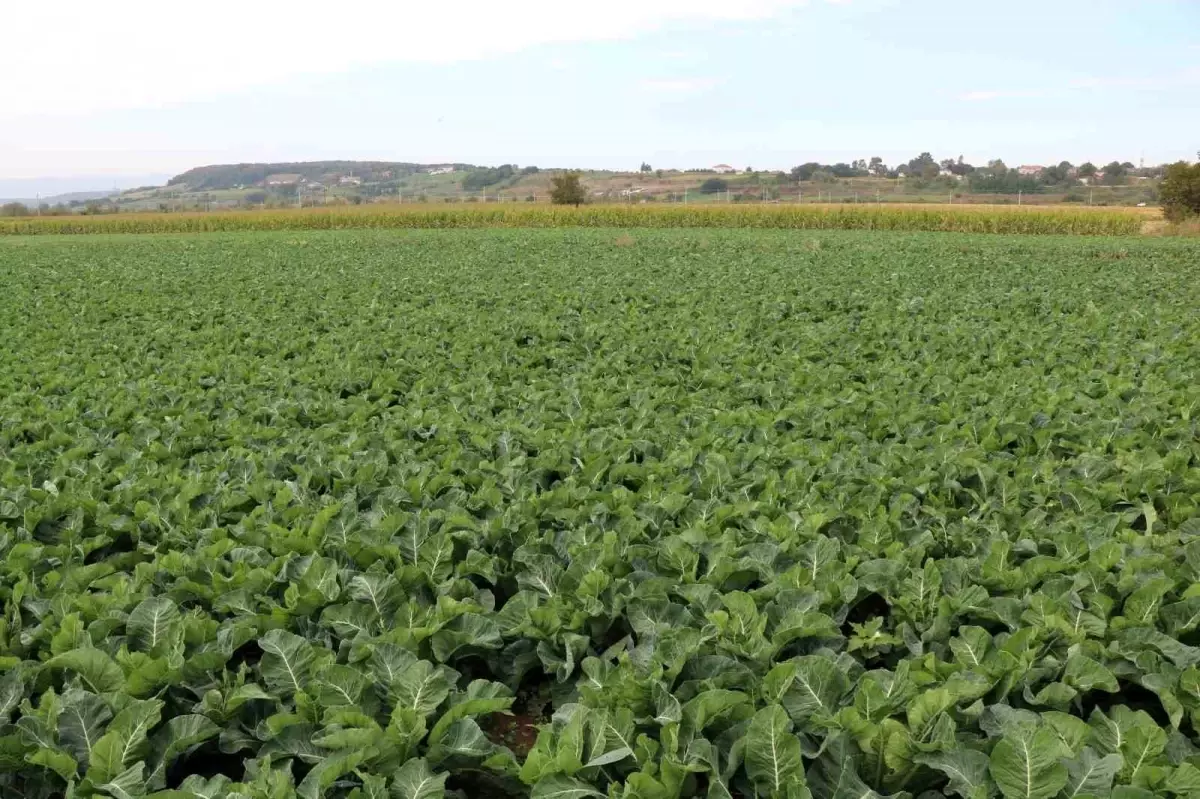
[0,0,1200,196]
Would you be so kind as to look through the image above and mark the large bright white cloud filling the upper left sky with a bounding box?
[0,0,833,119]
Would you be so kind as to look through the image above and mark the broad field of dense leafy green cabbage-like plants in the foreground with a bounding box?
[0,225,1200,799]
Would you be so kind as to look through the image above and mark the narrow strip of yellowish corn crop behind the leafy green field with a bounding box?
[0,203,1160,236]
